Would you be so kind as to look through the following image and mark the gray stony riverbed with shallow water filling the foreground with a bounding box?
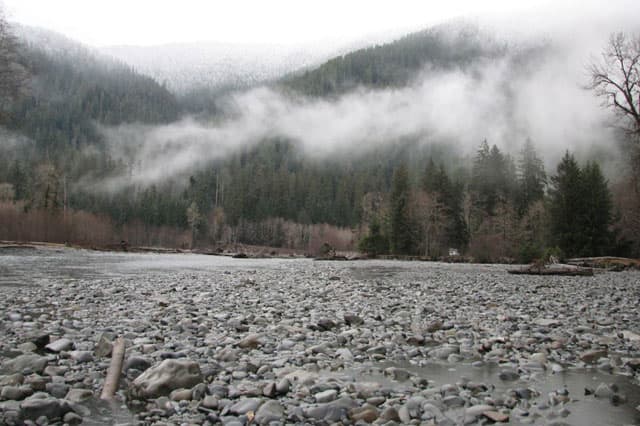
[0,248,640,425]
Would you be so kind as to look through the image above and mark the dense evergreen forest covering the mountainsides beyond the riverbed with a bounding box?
[0,16,640,261]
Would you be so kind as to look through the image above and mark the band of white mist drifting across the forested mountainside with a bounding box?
[90,36,613,189]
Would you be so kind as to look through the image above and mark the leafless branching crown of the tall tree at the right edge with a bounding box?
[589,33,640,136]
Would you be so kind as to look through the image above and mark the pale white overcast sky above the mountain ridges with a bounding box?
[5,0,640,46]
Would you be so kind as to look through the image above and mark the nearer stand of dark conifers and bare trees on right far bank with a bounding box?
[359,141,620,262]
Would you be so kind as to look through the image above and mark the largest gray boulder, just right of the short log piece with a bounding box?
[129,359,203,399]
